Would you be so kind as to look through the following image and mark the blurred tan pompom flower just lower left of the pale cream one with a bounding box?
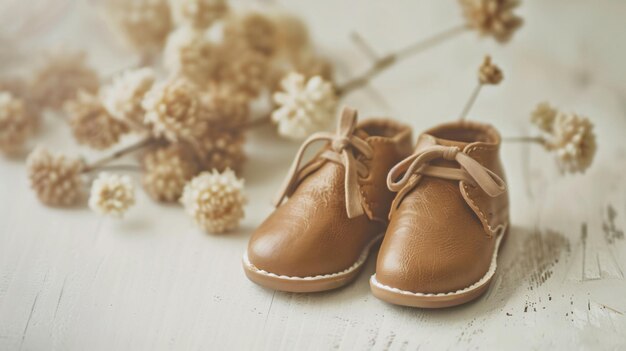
[65,91,129,150]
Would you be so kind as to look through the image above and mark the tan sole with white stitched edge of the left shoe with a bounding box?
[242,234,384,292]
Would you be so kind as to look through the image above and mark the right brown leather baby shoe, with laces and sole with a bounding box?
[370,122,509,308]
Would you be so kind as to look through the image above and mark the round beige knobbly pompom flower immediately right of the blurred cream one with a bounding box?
[141,79,206,141]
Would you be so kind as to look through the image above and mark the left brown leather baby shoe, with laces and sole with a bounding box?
[243,108,412,292]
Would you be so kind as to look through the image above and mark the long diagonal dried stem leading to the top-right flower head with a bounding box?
[337,24,468,96]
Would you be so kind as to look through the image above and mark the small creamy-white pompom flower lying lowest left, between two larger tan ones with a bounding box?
[89,172,135,217]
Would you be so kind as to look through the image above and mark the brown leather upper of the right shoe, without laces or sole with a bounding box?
[376,122,509,294]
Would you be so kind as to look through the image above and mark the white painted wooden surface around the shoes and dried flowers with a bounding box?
[0,0,626,350]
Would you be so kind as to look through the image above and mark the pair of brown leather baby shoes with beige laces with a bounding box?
[243,108,509,308]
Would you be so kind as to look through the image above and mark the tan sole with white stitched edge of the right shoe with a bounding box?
[370,225,507,308]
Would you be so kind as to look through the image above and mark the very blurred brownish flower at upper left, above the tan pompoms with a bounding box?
[30,52,100,109]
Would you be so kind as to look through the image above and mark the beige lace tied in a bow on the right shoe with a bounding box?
[387,145,506,216]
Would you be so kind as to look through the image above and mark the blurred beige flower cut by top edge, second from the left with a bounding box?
[171,0,228,29]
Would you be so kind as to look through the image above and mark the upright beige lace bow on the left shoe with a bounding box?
[274,107,373,218]
